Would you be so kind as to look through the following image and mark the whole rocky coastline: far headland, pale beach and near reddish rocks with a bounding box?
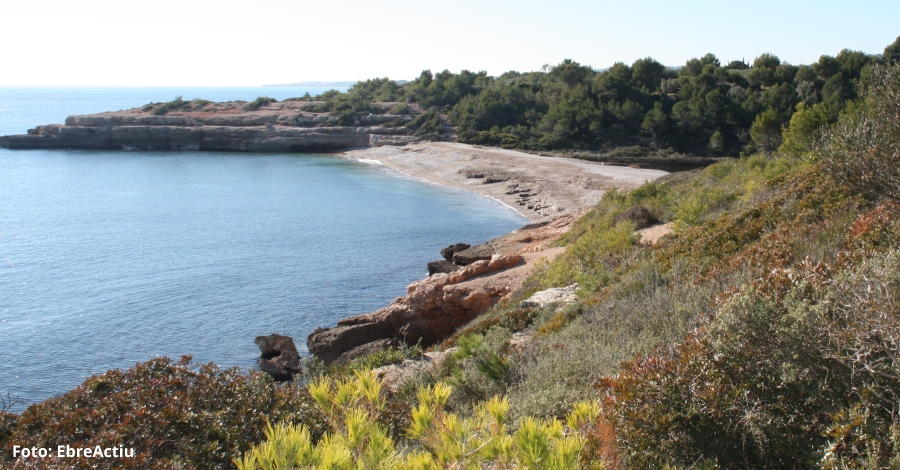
[0,101,666,370]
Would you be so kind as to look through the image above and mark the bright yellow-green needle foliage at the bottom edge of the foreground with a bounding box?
[235,372,599,470]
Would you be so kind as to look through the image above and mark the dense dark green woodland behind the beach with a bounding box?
[300,35,900,157]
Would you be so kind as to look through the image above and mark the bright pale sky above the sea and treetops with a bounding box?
[0,0,900,86]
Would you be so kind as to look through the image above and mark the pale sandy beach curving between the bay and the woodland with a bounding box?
[342,142,667,222]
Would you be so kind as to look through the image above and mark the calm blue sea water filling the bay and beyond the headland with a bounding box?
[0,88,527,411]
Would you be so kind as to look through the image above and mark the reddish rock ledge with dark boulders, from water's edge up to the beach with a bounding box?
[307,215,576,364]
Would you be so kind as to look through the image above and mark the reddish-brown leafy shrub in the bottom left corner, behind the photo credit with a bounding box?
[0,356,325,469]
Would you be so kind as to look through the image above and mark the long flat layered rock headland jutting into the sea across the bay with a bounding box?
[0,102,452,152]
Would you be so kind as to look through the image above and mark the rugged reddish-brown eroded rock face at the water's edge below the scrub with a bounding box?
[306,254,523,364]
